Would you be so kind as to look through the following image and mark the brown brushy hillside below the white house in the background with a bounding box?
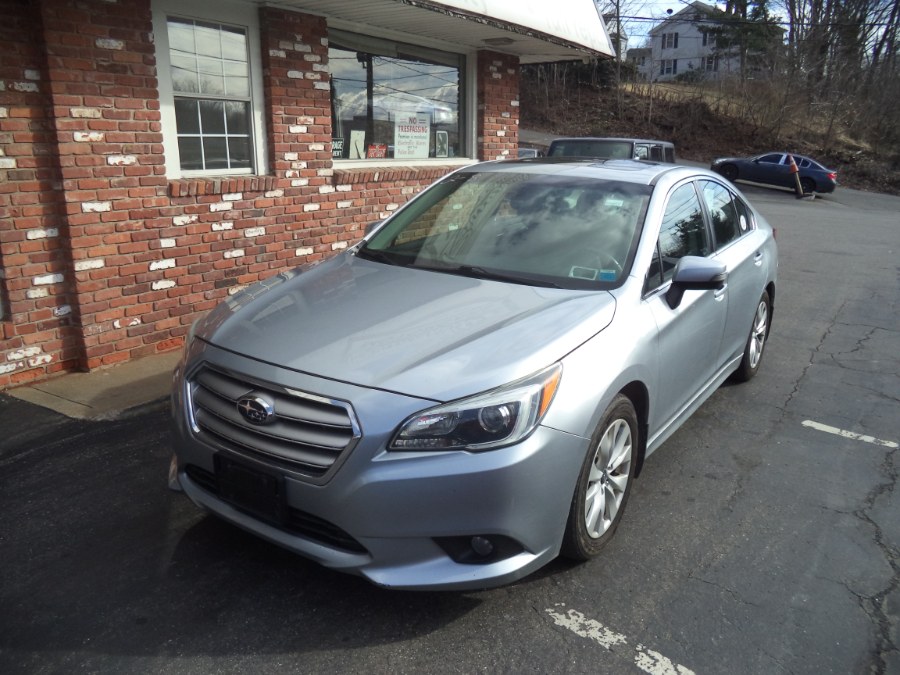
[520,74,900,195]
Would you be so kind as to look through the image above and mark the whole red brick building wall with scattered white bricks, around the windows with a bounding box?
[0,0,518,389]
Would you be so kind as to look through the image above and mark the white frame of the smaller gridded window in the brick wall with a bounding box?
[152,0,269,178]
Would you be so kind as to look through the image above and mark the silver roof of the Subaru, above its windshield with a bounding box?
[460,157,719,185]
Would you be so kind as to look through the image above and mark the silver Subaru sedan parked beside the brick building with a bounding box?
[170,159,778,589]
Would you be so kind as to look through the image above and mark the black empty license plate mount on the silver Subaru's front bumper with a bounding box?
[215,454,284,523]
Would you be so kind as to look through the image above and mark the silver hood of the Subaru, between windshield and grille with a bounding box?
[195,253,615,401]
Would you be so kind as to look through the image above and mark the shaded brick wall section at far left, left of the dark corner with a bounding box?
[0,0,81,385]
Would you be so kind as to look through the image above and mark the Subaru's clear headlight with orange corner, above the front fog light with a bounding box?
[388,363,562,452]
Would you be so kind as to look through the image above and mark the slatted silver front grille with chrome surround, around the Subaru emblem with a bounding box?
[189,366,359,479]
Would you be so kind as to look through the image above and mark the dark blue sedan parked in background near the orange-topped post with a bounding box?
[710,152,837,193]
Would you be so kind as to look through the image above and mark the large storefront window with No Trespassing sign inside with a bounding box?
[328,31,466,160]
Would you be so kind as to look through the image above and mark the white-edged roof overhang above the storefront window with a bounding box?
[265,0,613,63]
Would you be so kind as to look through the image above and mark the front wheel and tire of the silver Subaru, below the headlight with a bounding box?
[561,394,640,561]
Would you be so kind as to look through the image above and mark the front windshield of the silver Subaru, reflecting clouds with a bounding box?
[359,172,651,288]
